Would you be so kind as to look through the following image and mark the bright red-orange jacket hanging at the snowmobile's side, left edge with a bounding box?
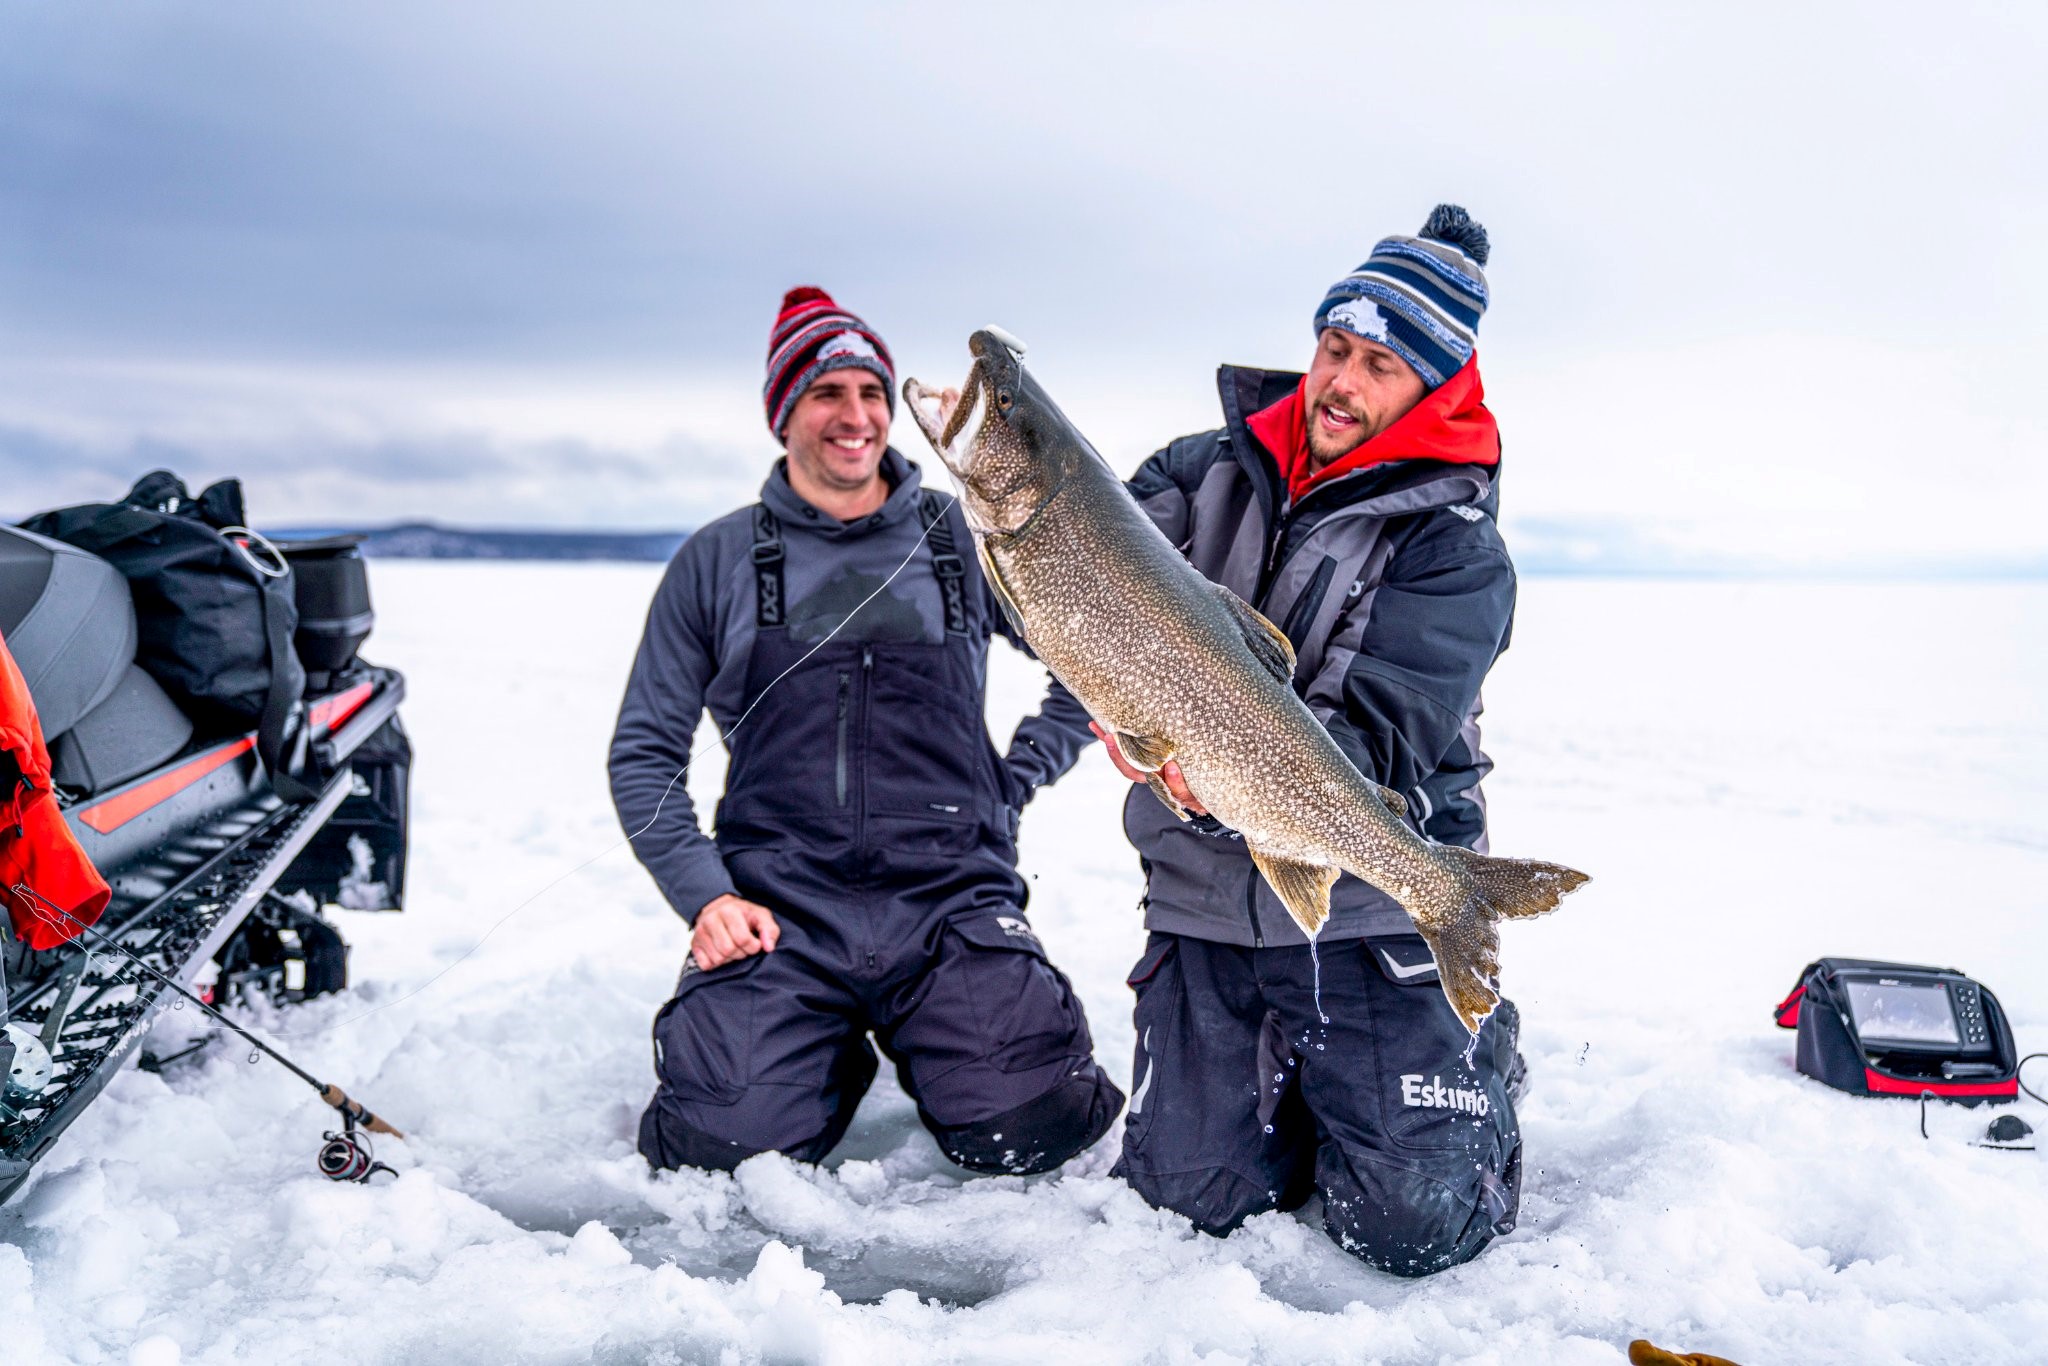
[0,641,111,948]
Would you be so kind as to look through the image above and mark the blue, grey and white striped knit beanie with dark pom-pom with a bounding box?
[1315,205,1491,389]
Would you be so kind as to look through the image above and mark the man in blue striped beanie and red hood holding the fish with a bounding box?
[1110,205,1522,1276]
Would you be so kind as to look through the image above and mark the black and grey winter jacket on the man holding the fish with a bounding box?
[1124,367,1516,944]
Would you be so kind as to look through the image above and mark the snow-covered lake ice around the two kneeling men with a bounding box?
[0,561,2048,1366]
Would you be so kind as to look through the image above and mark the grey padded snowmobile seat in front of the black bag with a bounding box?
[0,526,193,795]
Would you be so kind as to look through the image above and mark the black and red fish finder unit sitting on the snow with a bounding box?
[1776,958,2019,1106]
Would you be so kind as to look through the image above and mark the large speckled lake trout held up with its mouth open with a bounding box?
[903,328,1585,1034]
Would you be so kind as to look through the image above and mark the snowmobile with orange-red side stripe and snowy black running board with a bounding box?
[0,526,412,1202]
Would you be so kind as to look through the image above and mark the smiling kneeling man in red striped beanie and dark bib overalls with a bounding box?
[610,287,1124,1173]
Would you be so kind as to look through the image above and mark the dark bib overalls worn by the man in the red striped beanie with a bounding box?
[641,496,1122,1171]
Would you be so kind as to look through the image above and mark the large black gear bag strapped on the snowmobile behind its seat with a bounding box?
[23,469,317,801]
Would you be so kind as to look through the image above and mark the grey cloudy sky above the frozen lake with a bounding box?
[0,0,2048,563]
